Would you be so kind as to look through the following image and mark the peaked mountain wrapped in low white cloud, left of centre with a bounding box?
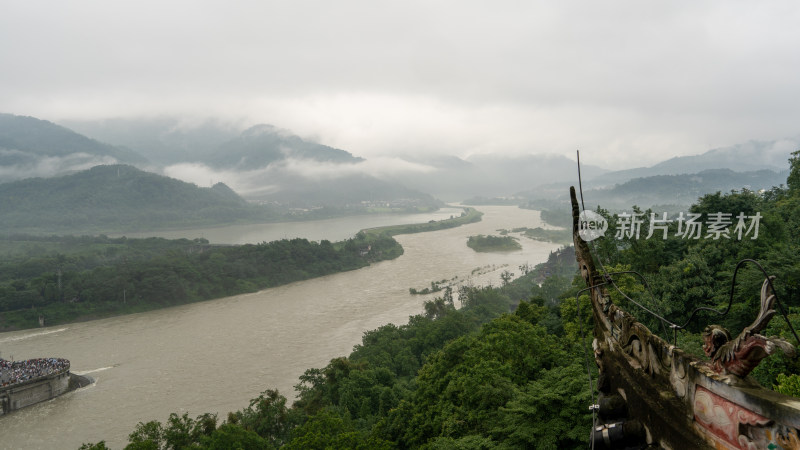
[173,124,441,207]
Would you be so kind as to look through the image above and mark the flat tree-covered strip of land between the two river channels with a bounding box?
[0,209,481,331]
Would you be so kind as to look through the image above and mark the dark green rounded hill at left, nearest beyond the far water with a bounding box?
[0,165,270,234]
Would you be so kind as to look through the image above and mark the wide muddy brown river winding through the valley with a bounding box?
[0,206,558,449]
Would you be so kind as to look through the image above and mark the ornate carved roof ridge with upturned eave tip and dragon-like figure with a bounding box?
[570,187,800,450]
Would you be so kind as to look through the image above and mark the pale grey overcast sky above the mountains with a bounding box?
[0,0,800,168]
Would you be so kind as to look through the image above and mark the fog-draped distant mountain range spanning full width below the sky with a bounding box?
[0,114,800,225]
